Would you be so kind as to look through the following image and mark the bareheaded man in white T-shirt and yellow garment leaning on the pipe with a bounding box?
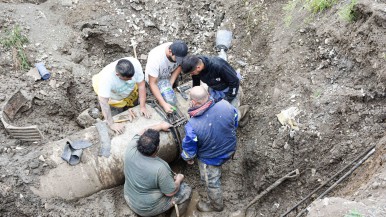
[92,57,150,134]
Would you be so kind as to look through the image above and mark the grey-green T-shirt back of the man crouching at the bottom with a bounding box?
[124,135,175,216]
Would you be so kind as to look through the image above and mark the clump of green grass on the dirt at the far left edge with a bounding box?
[0,26,31,70]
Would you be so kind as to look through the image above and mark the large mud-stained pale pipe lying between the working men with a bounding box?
[31,93,188,200]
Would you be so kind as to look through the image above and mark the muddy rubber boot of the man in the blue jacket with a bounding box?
[197,188,224,212]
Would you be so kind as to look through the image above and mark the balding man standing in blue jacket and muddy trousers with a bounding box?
[181,86,238,212]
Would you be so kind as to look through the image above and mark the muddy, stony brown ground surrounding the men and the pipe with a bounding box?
[0,0,386,216]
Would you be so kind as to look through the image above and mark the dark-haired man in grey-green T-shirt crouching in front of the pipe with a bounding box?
[124,122,192,216]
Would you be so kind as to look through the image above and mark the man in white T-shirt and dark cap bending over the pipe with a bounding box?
[145,40,188,113]
